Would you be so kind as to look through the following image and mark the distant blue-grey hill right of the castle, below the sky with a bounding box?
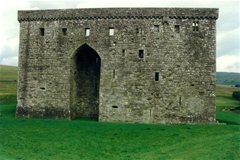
[216,72,240,85]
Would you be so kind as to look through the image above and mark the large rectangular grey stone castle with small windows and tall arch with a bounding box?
[16,8,218,124]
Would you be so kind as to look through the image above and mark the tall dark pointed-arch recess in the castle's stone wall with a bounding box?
[71,44,101,119]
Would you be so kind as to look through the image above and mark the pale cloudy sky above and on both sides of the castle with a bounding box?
[0,0,240,73]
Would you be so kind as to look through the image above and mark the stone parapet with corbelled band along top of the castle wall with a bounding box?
[18,8,218,22]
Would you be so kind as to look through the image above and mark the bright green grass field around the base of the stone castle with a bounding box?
[0,65,240,160]
